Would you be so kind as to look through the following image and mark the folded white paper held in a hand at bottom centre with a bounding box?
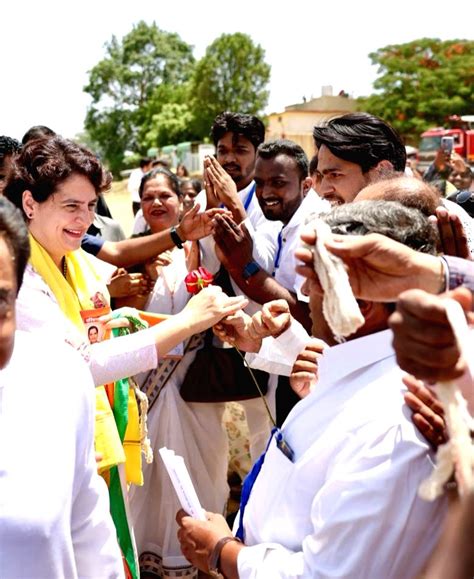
[159,446,206,521]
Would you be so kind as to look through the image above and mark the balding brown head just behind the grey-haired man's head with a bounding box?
[354,177,441,215]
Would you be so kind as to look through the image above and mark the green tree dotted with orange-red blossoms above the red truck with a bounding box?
[359,38,474,142]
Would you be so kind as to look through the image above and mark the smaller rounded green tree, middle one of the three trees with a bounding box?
[191,32,270,137]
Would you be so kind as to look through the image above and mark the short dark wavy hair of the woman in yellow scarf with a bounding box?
[3,135,112,216]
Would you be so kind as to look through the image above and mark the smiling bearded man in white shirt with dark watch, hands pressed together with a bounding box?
[214,139,330,424]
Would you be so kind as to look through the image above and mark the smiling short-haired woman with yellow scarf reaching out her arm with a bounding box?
[5,136,246,576]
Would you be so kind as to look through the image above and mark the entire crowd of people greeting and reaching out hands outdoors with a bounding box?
[0,112,474,579]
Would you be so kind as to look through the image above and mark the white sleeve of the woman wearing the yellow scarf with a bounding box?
[16,264,157,386]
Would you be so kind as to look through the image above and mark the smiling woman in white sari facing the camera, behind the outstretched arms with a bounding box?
[122,169,228,577]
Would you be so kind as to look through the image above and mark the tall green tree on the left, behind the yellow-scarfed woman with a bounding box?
[84,22,194,173]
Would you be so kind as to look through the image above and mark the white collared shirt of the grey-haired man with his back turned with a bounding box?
[238,331,445,579]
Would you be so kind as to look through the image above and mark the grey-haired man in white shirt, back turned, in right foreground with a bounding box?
[177,201,445,579]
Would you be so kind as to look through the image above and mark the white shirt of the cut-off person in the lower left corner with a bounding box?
[0,332,124,579]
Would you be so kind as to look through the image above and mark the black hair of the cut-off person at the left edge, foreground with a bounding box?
[0,196,30,293]
